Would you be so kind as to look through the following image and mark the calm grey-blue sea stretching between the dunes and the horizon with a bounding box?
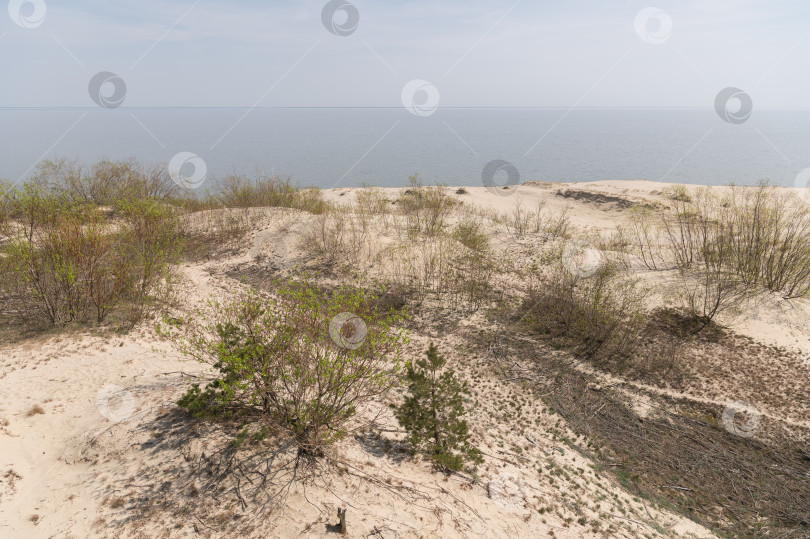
[0,108,810,188]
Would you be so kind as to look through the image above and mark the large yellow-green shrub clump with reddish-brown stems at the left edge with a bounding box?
[0,184,180,326]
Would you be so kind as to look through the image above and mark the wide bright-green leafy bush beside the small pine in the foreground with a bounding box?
[174,280,407,456]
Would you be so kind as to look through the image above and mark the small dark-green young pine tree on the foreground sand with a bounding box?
[392,343,483,471]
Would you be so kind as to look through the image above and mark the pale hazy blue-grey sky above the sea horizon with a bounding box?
[0,0,810,109]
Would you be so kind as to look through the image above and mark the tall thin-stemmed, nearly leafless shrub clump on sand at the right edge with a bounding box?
[629,184,810,331]
